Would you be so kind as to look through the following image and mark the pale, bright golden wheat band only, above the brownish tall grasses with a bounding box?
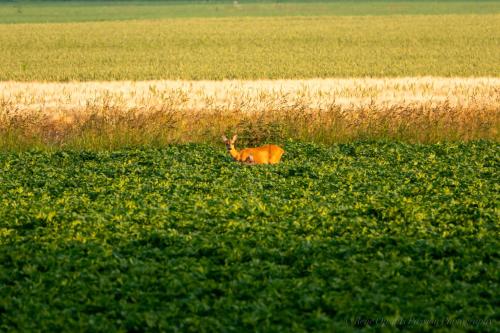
[0,77,500,115]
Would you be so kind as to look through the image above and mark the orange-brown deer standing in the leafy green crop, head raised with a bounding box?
[222,135,285,164]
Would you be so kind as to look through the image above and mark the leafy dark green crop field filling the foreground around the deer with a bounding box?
[0,142,500,332]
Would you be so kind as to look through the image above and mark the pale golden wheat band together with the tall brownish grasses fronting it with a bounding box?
[0,77,500,147]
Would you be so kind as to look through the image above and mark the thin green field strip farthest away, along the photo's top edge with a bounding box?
[0,0,500,23]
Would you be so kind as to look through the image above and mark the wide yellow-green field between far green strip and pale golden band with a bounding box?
[0,14,500,81]
